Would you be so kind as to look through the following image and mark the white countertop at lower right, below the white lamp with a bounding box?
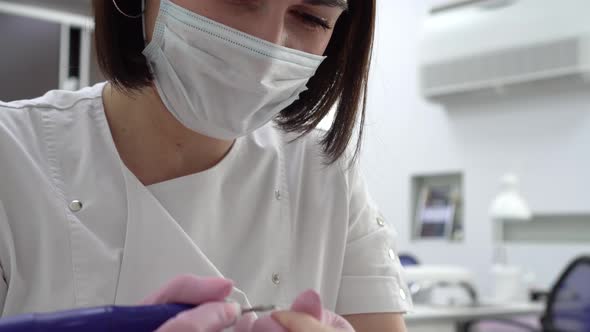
[405,303,545,323]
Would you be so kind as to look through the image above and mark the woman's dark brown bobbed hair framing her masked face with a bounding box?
[93,0,376,163]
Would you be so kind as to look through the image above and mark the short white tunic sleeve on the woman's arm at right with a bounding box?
[336,167,412,315]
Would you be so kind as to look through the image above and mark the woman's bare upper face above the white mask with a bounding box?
[146,0,349,55]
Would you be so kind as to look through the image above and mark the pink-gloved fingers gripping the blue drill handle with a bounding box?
[142,275,240,332]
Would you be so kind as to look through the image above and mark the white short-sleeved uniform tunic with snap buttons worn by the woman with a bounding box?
[0,84,410,316]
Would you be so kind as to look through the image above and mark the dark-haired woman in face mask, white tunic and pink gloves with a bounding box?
[0,0,410,332]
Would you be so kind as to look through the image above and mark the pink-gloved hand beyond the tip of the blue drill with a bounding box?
[235,290,354,332]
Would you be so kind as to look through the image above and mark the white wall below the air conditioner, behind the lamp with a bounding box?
[362,0,590,293]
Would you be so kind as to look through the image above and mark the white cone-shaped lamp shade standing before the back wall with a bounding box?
[490,174,532,221]
